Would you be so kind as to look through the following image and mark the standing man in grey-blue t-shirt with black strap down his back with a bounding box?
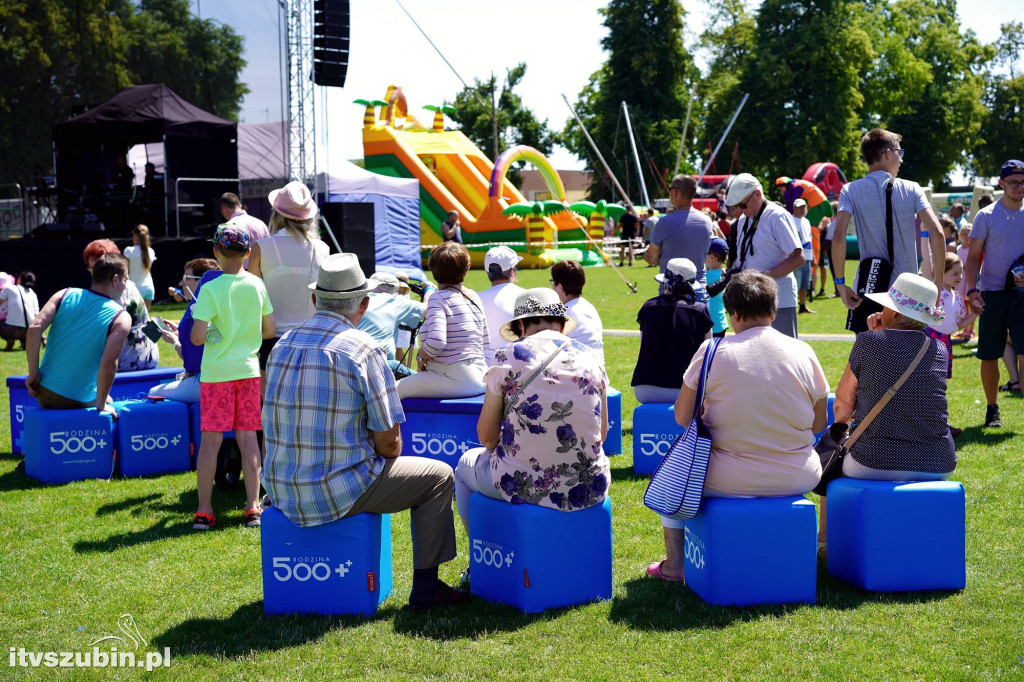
[831,128,946,334]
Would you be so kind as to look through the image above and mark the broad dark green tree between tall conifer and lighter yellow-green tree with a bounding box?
[705,0,874,179]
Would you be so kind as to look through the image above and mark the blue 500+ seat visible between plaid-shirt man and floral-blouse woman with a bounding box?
[401,395,483,469]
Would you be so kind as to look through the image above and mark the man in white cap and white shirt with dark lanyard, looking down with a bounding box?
[725,173,804,339]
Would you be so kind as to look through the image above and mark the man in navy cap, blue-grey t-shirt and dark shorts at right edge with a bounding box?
[964,159,1024,427]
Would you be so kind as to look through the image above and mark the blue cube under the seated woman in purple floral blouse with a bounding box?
[469,493,611,613]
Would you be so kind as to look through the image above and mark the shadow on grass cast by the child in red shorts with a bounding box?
[72,486,246,554]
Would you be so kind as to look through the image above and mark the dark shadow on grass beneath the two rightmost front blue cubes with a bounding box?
[608,560,959,632]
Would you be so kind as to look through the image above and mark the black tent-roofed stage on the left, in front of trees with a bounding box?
[47,84,239,238]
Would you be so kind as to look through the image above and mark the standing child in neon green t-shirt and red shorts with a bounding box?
[191,224,274,530]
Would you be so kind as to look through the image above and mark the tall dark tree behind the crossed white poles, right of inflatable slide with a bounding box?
[563,0,698,201]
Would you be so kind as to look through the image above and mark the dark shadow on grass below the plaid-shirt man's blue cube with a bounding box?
[152,601,382,657]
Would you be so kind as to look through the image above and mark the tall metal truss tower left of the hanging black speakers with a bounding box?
[282,0,316,184]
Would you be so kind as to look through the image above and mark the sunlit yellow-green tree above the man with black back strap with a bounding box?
[862,0,994,186]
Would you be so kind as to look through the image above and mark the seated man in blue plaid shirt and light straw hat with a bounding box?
[262,254,468,610]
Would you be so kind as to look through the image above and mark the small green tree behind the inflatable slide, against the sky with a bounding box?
[449,62,555,187]
